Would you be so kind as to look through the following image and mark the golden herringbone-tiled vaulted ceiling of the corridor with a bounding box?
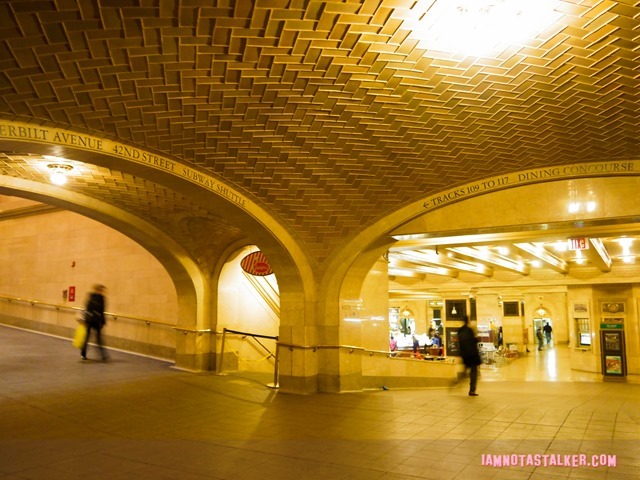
[0,0,640,266]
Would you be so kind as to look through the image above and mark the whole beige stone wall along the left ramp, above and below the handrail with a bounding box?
[0,204,178,359]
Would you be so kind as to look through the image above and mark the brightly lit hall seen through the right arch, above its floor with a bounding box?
[332,171,640,388]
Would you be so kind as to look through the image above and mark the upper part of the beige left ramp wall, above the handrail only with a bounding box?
[0,211,177,323]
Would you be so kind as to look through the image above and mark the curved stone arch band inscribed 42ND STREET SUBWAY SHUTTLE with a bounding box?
[0,120,317,292]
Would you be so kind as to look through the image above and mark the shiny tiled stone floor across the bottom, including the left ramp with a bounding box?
[0,326,640,480]
